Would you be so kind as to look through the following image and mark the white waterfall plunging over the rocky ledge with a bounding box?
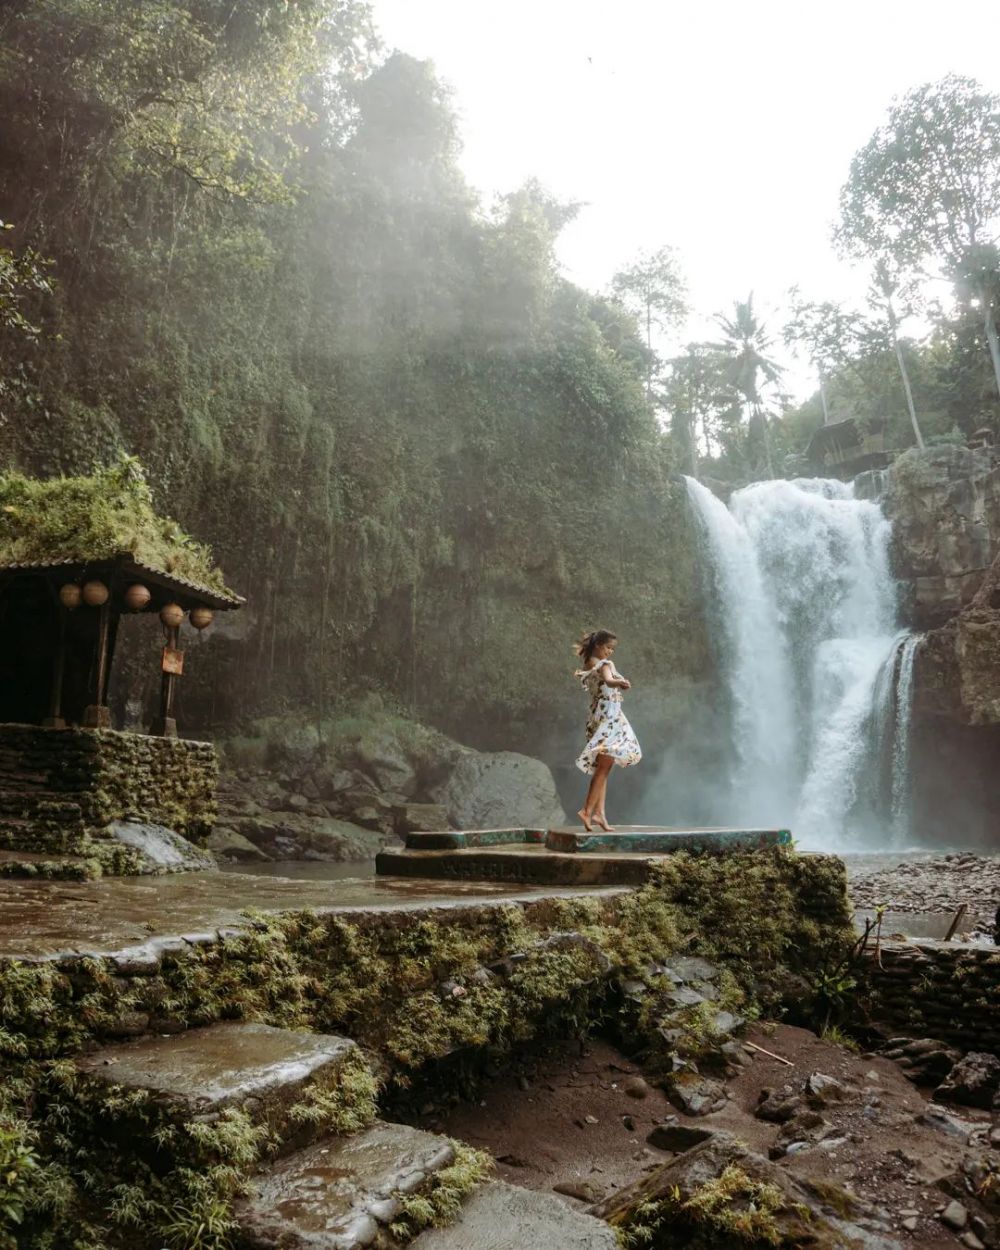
[686,478,919,848]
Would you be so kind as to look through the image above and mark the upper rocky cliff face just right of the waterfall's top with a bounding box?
[883,446,1000,630]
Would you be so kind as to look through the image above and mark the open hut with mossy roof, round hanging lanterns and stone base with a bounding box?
[0,456,244,876]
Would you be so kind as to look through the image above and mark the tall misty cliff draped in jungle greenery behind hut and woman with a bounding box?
[0,7,709,759]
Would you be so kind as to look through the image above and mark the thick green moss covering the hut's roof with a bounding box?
[0,455,231,595]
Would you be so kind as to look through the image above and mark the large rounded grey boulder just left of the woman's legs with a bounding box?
[431,751,566,829]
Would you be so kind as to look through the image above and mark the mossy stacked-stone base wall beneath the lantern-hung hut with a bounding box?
[0,725,219,855]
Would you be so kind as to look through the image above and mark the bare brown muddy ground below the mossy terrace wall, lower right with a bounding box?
[400,1024,990,1250]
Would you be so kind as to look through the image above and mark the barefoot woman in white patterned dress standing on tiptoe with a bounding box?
[574,629,643,834]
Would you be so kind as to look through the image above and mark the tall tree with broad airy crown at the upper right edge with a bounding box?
[836,74,1000,393]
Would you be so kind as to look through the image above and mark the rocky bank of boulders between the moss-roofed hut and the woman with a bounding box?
[209,709,565,863]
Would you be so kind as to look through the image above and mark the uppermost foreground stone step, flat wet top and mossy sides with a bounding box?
[75,1023,376,1165]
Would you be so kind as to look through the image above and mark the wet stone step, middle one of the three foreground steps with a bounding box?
[234,1121,471,1250]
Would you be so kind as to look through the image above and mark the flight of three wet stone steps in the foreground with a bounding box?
[76,1024,616,1250]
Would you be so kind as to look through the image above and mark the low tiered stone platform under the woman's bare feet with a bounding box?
[375,825,791,886]
